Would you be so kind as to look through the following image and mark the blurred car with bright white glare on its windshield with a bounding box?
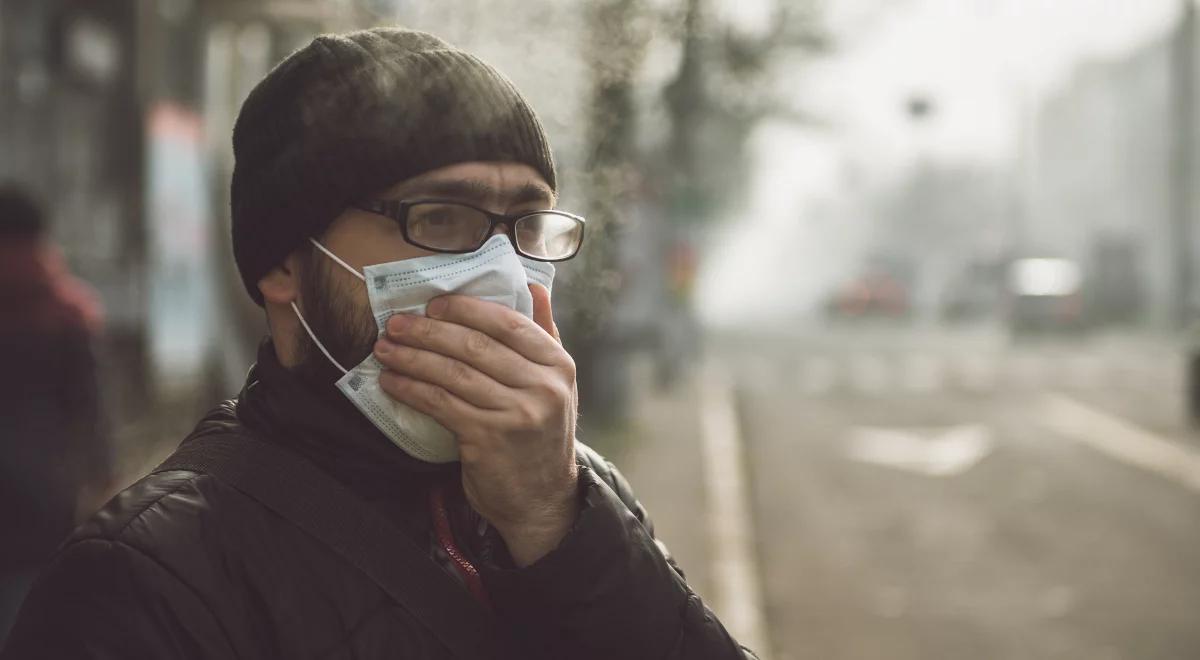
[1008,258,1084,335]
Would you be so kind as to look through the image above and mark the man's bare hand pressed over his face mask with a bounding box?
[374,286,578,566]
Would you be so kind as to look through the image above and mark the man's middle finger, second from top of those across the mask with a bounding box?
[385,312,540,388]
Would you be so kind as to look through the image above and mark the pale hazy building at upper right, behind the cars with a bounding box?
[1019,6,1200,328]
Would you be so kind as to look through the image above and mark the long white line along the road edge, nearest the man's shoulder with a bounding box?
[700,362,772,660]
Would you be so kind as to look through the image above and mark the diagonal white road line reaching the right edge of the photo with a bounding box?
[1043,394,1200,492]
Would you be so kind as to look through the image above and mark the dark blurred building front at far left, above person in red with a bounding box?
[0,0,145,432]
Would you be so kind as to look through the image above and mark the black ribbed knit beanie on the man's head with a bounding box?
[230,28,557,305]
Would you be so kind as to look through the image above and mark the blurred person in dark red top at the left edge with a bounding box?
[0,185,112,640]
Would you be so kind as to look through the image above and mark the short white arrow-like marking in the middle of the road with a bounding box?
[846,424,995,476]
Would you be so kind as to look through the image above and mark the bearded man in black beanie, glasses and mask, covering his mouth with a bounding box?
[5,29,745,659]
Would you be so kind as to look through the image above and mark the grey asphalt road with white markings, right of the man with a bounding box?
[622,330,1200,660]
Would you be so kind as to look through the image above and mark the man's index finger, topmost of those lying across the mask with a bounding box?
[426,295,565,366]
